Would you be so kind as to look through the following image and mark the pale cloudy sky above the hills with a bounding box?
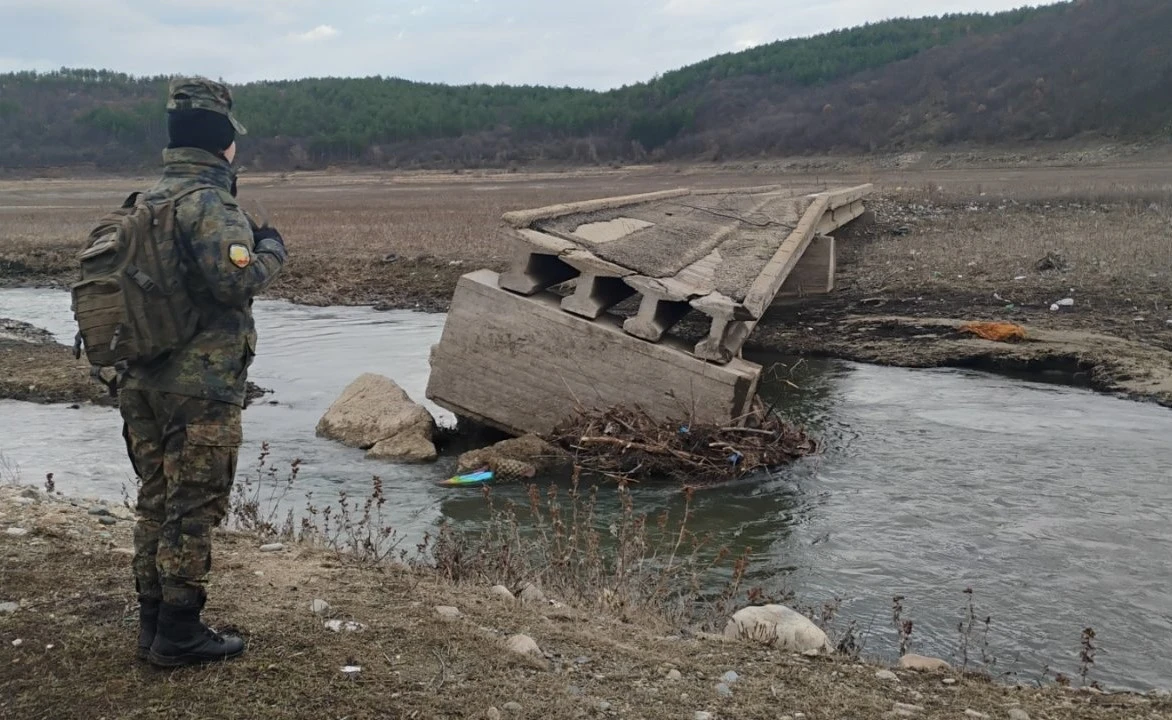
[0,0,1037,89]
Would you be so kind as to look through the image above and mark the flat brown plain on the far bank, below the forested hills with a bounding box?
[0,154,1172,405]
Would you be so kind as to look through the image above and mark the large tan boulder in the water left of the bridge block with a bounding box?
[318,373,437,462]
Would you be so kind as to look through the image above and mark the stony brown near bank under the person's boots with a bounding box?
[0,485,1172,720]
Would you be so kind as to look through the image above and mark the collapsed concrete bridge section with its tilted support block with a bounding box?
[428,185,871,434]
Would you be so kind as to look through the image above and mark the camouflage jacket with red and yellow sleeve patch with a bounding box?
[122,148,286,406]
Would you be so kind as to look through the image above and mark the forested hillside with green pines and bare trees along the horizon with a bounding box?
[0,0,1172,169]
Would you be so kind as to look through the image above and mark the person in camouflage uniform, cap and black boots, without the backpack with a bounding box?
[120,77,286,667]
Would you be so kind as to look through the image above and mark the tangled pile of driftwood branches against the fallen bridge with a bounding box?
[548,401,818,485]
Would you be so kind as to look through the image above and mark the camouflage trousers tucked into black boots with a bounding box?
[118,389,241,607]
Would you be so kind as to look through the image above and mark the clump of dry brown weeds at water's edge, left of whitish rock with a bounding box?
[416,469,765,630]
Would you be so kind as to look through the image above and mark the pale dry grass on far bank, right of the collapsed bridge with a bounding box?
[844,192,1172,312]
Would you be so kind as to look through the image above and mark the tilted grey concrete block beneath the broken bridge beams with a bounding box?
[427,271,761,434]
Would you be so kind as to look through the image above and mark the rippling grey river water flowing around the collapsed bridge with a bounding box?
[0,290,1172,691]
